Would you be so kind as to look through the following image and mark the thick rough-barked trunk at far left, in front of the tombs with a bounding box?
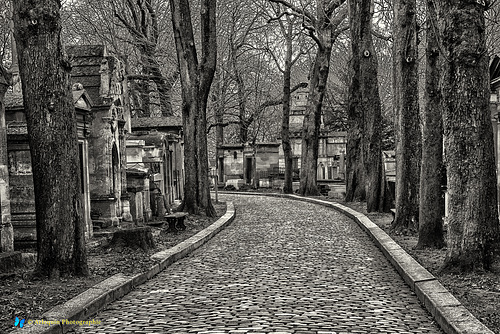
[14,0,88,278]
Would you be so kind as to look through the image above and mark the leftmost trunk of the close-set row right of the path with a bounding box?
[347,0,385,212]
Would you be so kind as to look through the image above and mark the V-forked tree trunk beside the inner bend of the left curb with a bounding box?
[170,0,217,217]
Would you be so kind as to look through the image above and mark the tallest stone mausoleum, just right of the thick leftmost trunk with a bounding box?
[66,45,131,225]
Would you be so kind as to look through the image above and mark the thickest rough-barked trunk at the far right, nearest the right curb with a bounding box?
[436,0,500,272]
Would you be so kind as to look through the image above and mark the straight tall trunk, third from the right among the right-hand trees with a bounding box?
[392,0,421,232]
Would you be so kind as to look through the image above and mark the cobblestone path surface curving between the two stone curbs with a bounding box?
[73,195,442,334]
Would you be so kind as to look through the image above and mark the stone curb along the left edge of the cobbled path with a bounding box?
[11,202,235,334]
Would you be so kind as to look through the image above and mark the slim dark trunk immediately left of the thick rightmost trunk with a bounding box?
[417,0,444,248]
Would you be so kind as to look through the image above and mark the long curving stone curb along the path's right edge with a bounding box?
[221,192,495,334]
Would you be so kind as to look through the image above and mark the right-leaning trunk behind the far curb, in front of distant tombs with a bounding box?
[300,44,333,196]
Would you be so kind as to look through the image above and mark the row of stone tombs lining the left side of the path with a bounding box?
[2,46,183,249]
